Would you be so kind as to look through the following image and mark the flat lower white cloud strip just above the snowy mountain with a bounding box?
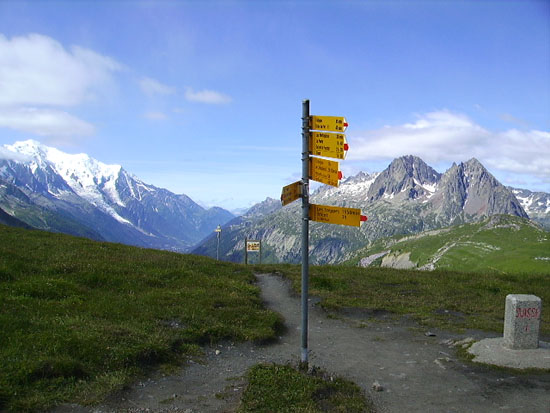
[0,107,95,137]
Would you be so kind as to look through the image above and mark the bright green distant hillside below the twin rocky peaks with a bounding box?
[350,215,550,274]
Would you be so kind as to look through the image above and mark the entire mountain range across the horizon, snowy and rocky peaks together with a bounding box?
[0,140,550,264]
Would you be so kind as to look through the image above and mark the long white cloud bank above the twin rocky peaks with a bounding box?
[347,110,550,185]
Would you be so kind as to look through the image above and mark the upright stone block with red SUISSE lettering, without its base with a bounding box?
[503,294,542,350]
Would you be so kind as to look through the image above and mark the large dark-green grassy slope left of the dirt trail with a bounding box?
[0,226,281,411]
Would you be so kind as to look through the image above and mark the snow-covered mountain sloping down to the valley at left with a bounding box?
[0,140,234,251]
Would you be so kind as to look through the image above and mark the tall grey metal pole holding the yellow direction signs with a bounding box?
[301,99,309,367]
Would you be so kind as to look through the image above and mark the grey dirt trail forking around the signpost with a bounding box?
[55,275,550,413]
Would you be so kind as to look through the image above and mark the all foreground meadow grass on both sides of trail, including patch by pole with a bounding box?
[0,222,550,412]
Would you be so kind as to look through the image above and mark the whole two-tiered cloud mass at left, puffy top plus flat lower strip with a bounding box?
[0,34,123,143]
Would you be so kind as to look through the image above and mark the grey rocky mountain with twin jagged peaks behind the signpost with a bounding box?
[194,155,548,264]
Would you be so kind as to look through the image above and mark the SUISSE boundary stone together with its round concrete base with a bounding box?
[468,294,550,370]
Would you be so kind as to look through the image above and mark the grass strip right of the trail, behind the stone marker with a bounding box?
[256,265,550,337]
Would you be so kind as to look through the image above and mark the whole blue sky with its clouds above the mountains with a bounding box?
[0,0,550,209]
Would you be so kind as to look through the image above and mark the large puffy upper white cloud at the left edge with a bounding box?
[0,34,122,106]
